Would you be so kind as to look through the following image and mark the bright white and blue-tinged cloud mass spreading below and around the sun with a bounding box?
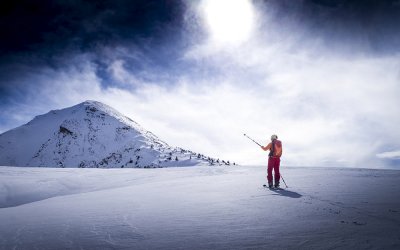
[0,0,400,167]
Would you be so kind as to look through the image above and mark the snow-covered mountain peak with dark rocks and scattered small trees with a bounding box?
[0,101,230,168]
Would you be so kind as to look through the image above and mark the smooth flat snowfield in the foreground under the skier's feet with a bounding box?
[0,166,400,249]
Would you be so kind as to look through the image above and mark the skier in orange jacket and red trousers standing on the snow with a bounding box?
[261,135,282,188]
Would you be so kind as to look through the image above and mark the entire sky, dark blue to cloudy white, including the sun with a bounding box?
[0,0,400,169]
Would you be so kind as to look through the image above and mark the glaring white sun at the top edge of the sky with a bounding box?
[202,0,254,44]
